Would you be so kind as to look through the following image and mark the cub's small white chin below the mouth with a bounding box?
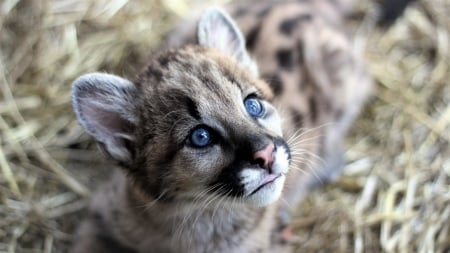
[245,175,286,207]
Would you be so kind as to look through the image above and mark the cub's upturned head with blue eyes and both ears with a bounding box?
[73,9,290,206]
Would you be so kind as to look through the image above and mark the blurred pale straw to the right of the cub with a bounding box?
[296,0,450,253]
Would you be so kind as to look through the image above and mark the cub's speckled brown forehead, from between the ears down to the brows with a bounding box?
[138,47,271,123]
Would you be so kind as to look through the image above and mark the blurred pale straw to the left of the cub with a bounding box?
[0,0,188,252]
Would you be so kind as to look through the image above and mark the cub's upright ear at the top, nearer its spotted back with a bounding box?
[197,8,258,75]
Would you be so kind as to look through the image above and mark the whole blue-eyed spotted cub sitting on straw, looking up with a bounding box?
[71,0,371,253]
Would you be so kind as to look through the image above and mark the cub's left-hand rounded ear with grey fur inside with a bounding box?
[72,73,137,162]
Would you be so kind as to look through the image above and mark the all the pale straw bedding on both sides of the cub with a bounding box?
[0,0,450,252]
